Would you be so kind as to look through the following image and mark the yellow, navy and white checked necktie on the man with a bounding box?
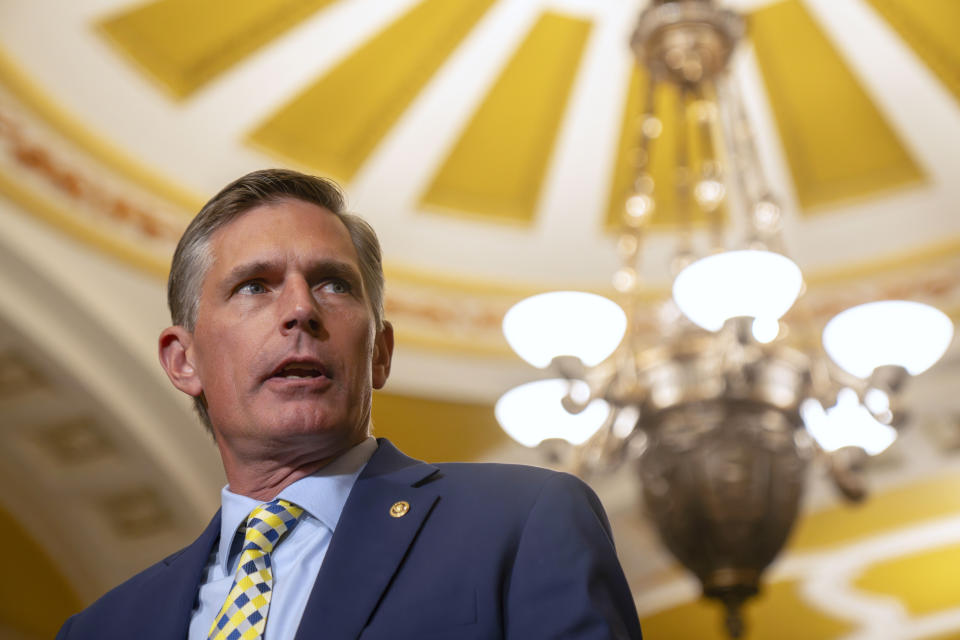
[209,499,303,640]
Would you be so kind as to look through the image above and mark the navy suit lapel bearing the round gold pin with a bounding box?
[296,439,439,640]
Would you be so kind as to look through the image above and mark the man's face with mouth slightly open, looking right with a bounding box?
[180,199,392,451]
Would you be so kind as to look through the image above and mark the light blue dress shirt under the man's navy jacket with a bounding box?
[189,437,377,640]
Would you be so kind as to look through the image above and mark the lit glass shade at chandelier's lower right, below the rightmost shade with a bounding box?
[800,388,897,456]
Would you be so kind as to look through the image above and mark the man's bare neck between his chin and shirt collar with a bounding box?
[217,434,366,502]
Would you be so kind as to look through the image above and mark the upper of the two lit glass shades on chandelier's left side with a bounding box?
[503,291,627,369]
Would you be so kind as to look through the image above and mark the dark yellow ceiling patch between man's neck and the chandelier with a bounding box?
[373,391,510,462]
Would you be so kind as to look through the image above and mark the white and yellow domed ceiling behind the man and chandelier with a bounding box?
[0,0,960,638]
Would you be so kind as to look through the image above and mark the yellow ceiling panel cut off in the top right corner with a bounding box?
[867,0,960,105]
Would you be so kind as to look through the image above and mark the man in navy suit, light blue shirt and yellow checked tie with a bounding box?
[58,170,640,640]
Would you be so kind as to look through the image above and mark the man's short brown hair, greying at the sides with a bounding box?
[167,169,384,429]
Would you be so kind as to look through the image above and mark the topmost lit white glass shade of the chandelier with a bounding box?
[673,249,803,331]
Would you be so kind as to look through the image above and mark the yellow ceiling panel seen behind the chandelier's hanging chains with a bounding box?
[606,65,725,229]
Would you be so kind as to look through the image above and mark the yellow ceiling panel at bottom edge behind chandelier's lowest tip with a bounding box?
[640,581,853,640]
